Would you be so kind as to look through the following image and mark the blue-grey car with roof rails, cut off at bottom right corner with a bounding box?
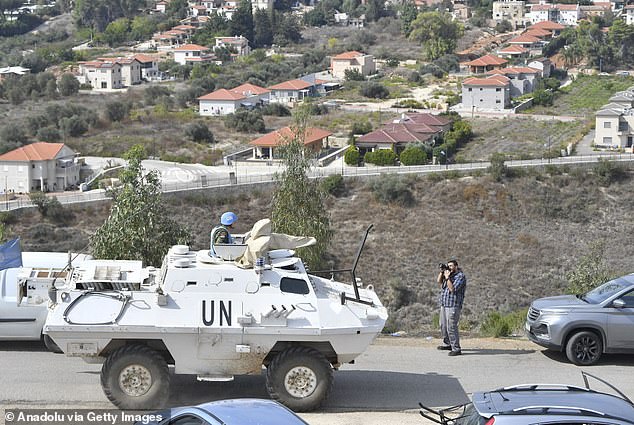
[420,372,634,425]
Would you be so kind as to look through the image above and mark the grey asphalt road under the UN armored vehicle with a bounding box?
[0,338,634,425]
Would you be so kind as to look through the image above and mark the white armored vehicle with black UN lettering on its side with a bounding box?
[44,220,387,411]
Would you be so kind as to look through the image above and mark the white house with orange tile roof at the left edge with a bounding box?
[0,142,81,193]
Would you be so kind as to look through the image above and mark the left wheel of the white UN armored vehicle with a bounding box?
[101,345,170,410]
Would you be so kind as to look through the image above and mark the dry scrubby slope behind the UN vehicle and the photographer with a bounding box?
[8,166,634,334]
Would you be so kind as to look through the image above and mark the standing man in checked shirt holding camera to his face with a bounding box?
[437,260,467,356]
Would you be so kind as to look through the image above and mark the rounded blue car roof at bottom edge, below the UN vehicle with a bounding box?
[168,398,308,425]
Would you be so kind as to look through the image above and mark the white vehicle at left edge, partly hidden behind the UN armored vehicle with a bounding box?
[0,252,92,349]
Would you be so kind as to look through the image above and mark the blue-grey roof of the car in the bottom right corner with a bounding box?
[472,385,634,423]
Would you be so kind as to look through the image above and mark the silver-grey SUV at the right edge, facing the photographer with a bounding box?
[525,274,634,366]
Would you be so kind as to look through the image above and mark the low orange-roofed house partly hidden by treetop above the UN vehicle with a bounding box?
[250,127,332,159]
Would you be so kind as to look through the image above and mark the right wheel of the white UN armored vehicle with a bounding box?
[266,347,333,412]
